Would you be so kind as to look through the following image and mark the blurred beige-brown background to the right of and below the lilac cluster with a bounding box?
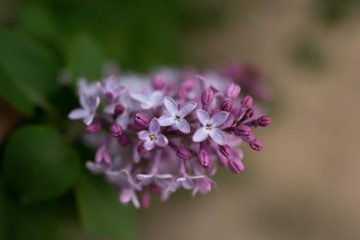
[138,0,360,240]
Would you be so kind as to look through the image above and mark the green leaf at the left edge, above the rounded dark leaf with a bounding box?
[0,29,58,115]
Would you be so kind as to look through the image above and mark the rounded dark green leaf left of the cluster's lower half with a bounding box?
[3,125,80,203]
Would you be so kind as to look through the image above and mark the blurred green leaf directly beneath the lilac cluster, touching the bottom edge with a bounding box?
[75,173,137,240]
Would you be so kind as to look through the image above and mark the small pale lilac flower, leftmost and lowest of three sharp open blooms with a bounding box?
[138,118,169,151]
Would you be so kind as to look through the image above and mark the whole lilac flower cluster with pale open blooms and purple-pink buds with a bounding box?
[69,63,271,208]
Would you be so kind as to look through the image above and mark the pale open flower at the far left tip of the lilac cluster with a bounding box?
[68,94,100,125]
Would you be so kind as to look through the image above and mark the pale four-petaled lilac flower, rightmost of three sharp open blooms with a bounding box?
[192,109,229,145]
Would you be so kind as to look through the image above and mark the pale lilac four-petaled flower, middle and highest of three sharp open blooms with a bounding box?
[159,97,197,134]
